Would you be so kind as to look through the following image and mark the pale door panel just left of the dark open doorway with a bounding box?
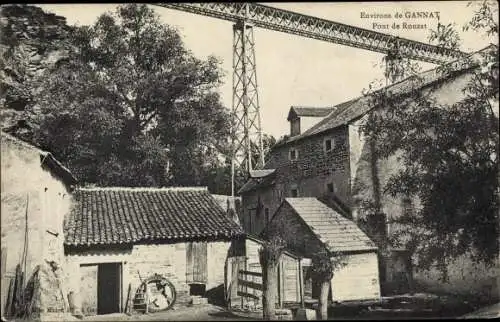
[80,265,98,315]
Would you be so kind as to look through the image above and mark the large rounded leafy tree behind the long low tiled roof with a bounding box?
[30,4,230,186]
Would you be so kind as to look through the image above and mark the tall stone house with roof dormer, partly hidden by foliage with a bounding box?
[239,47,498,300]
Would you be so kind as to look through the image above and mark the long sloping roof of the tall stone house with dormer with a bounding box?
[279,47,480,145]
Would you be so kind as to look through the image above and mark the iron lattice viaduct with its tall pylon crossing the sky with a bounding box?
[155,1,466,195]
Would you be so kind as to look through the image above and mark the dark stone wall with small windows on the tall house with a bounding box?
[242,127,350,235]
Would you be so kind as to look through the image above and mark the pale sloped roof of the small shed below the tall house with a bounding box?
[285,198,377,252]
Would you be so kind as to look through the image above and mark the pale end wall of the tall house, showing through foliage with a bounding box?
[349,70,499,298]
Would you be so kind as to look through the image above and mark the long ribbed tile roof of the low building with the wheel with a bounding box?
[65,188,243,246]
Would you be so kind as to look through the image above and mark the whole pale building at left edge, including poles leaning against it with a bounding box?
[1,131,76,318]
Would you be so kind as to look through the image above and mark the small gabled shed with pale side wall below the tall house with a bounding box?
[265,198,380,302]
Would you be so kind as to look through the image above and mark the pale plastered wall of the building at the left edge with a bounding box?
[1,136,70,312]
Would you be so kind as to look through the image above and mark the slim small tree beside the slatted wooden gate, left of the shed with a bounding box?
[259,235,285,320]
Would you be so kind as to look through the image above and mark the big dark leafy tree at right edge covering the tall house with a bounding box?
[362,1,499,279]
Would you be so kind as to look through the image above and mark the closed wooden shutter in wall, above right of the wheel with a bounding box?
[186,242,208,284]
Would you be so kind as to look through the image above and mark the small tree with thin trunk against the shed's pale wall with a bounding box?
[310,249,347,320]
